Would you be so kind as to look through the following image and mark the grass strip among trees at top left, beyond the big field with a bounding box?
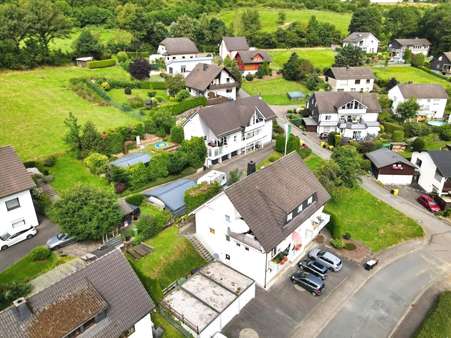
[50,27,132,52]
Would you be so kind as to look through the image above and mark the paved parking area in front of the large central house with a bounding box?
[224,252,359,338]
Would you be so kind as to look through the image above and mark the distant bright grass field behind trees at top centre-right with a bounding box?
[219,8,352,35]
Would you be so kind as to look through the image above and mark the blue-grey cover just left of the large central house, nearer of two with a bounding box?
[144,178,196,216]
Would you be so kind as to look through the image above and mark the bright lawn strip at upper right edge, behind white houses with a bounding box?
[373,66,451,88]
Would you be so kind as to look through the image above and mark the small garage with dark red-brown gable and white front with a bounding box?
[366,148,416,185]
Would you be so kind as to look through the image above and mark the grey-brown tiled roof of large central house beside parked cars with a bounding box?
[225,152,330,252]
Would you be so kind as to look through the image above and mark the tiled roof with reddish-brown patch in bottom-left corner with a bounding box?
[0,250,155,338]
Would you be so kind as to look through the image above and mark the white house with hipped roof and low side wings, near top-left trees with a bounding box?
[149,38,213,76]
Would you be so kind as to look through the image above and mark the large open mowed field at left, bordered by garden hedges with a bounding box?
[0,66,136,160]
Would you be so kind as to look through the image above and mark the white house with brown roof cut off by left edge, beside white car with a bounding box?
[0,146,39,234]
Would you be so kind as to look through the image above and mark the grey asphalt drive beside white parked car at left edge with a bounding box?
[0,219,58,272]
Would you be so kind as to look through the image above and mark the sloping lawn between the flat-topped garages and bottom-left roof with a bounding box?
[130,226,206,301]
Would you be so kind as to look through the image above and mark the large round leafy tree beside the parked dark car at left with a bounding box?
[51,186,122,240]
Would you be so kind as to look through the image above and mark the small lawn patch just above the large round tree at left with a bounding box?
[49,154,113,193]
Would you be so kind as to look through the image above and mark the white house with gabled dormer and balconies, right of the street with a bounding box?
[308,92,381,140]
